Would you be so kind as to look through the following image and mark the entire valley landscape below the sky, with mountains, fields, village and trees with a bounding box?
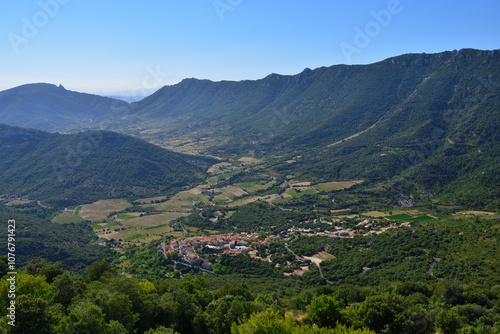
[0,49,500,334]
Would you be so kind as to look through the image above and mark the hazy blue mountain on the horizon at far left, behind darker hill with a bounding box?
[0,83,128,131]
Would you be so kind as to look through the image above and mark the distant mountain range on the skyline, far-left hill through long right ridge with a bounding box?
[0,49,500,207]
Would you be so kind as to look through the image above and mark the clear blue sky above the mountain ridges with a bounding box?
[0,0,500,94]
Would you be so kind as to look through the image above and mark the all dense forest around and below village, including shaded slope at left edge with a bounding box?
[0,198,500,334]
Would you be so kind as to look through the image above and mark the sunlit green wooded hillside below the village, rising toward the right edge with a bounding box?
[0,213,500,334]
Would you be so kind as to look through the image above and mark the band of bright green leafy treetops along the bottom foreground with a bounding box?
[0,257,500,334]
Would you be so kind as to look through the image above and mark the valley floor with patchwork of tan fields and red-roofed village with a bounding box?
[38,149,500,282]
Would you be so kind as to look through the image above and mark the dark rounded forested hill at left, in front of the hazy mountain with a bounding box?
[0,124,214,207]
